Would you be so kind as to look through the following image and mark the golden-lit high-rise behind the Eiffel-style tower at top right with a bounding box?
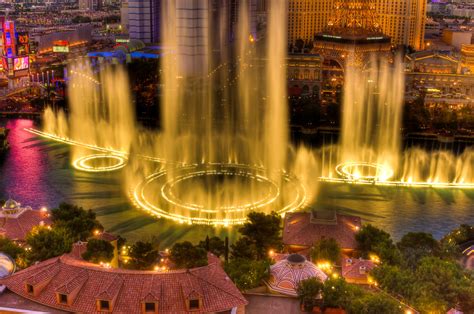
[288,0,426,50]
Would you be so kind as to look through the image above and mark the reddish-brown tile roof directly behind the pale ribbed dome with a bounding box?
[283,213,361,249]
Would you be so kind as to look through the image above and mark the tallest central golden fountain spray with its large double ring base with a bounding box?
[130,0,307,225]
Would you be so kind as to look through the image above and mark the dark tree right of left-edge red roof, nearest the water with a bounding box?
[51,203,104,241]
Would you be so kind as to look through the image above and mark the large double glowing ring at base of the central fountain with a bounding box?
[131,164,307,226]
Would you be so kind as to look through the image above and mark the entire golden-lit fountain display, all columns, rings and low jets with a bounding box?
[29,0,474,226]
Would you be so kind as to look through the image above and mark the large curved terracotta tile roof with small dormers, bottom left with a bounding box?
[0,254,247,314]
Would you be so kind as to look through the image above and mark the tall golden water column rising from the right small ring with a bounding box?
[340,57,404,180]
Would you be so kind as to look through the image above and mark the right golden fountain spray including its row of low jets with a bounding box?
[319,58,474,188]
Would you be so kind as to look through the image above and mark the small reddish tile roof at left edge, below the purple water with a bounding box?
[0,209,52,241]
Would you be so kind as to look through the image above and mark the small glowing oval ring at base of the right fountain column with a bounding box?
[336,162,393,182]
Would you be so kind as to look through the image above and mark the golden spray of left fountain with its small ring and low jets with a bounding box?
[43,62,135,172]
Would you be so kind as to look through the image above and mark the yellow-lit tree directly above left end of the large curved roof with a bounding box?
[26,227,73,262]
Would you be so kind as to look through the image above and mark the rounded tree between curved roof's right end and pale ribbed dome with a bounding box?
[224,258,270,290]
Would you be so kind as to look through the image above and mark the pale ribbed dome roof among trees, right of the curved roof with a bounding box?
[267,254,328,296]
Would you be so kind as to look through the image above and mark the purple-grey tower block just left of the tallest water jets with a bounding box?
[128,0,161,43]
